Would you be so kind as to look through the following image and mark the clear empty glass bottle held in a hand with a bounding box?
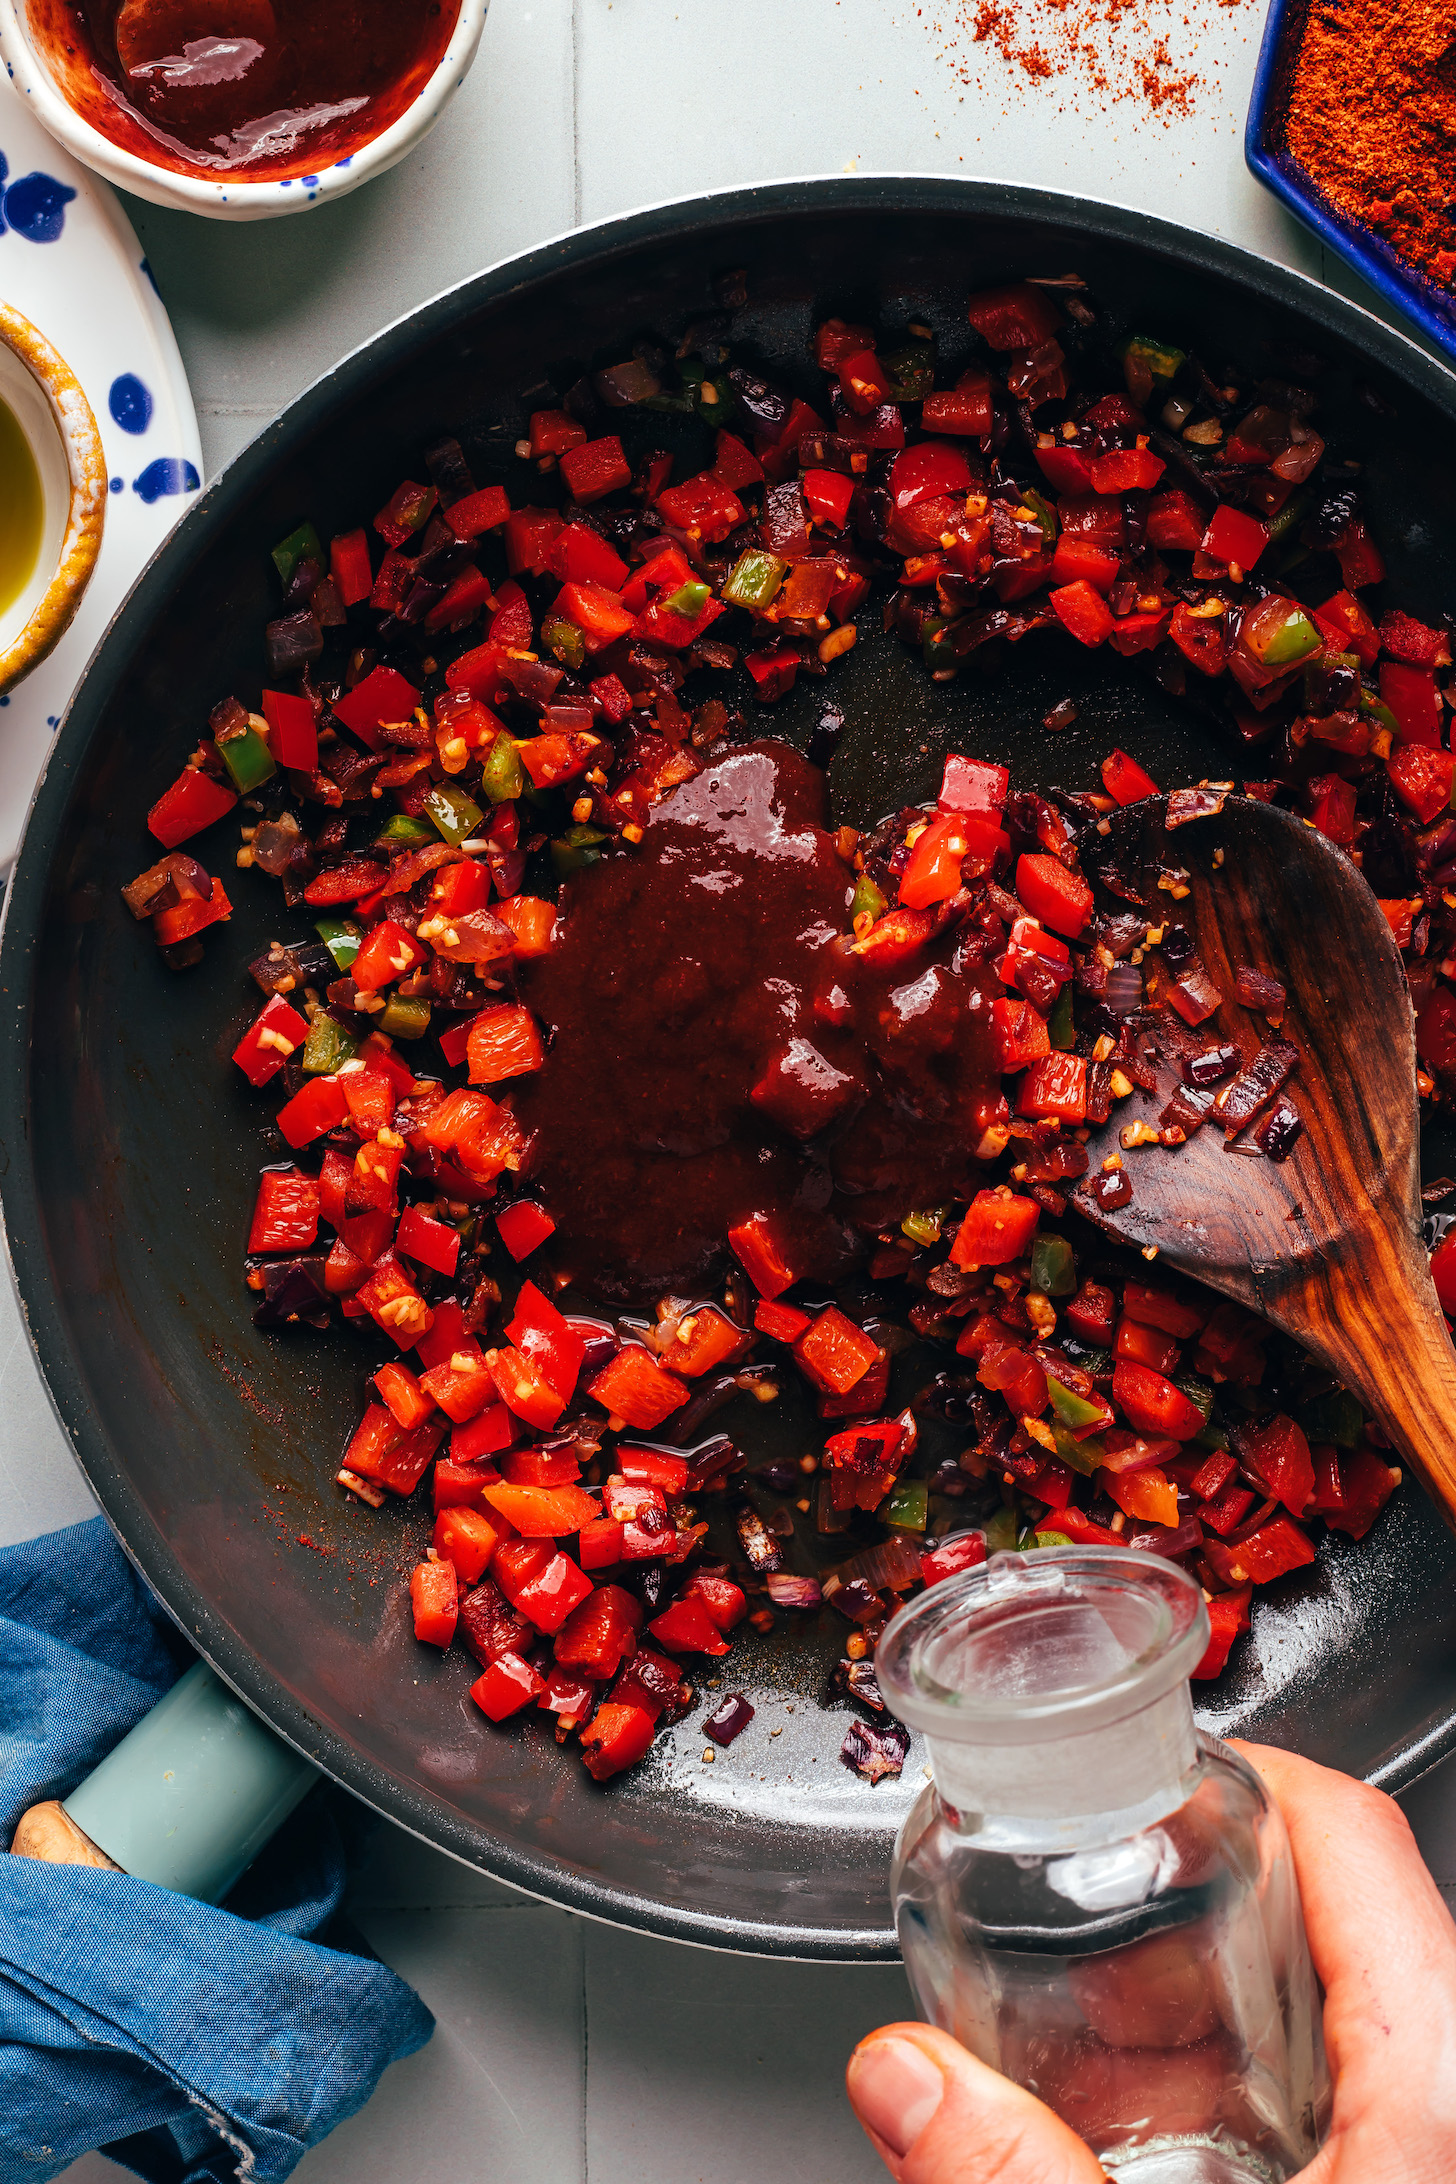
[878,1548,1329,2184]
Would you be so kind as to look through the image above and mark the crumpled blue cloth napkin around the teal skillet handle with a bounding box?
[0,1518,434,2184]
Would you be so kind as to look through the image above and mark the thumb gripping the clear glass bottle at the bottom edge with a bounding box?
[845,2025,1102,2184]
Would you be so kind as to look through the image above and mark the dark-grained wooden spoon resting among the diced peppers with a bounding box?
[1074,797,1456,1529]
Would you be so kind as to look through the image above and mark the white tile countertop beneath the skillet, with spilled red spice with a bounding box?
[0,0,1456,2184]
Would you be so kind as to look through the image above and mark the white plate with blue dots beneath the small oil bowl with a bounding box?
[0,74,203,874]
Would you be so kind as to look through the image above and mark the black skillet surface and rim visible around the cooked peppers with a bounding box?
[0,179,1456,1959]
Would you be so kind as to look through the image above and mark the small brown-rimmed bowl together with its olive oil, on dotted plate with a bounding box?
[0,301,107,695]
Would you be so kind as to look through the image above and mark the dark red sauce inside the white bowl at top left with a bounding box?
[28,0,461,181]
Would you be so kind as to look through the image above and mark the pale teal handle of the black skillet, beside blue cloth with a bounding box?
[61,1660,319,1904]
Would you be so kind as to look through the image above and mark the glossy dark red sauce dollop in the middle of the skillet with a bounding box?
[515,743,1000,1304]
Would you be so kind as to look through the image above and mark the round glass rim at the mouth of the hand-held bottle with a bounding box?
[875,1546,1209,1745]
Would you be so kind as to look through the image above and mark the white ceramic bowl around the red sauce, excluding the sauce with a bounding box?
[0,0,489,221]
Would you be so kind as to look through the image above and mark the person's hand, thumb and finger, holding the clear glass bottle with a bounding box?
[847,1745,1456,2184]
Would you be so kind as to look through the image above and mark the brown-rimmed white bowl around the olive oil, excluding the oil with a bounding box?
[0,304,107,695]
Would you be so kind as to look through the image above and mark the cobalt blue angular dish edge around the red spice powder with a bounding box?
[1244,0,1456,360]
